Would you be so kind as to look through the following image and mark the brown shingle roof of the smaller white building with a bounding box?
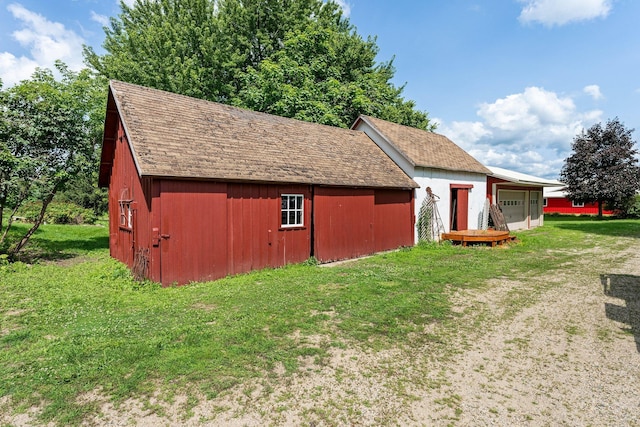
[356,115,491,174]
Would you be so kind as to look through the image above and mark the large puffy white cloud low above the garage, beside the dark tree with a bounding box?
[438,87,602,178]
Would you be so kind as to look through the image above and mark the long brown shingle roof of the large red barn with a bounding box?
[110,81,417,188]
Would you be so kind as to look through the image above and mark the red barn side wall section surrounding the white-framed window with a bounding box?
[149,179,311,285]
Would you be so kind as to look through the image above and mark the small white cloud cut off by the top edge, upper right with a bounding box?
[518,0,611,26]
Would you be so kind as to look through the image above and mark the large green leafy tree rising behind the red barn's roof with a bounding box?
[85,0,434,130]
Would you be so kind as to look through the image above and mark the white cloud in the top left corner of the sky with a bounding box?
[0,3,84,87]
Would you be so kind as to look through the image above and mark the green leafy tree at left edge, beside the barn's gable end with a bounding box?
[0,62,106,257]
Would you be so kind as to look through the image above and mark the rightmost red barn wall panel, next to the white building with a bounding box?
[373,190,414,252]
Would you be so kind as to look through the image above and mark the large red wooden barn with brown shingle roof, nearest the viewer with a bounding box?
[99,81,418,285]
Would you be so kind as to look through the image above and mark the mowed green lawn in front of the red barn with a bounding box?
[0,217,640,425]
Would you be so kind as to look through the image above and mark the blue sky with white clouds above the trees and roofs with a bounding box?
[0,0,640,178]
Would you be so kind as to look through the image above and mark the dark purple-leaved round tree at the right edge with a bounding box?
[560,118,640,216]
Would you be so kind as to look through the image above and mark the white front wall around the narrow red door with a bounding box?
[411,168,487,242]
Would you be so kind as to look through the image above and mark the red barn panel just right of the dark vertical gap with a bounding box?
[314,187,375,262]
